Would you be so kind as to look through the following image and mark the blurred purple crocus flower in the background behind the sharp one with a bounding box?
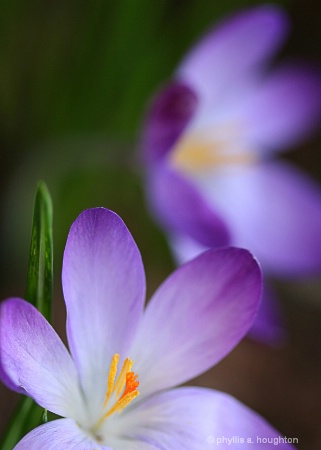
[142,6,321,342]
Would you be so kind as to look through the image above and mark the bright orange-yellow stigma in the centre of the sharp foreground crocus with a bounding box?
[96,353,139,429]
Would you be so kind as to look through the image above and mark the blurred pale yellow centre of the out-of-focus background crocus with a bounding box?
[171,131,255,174]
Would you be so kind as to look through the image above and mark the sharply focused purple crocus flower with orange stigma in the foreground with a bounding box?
[0,208,292,450]
